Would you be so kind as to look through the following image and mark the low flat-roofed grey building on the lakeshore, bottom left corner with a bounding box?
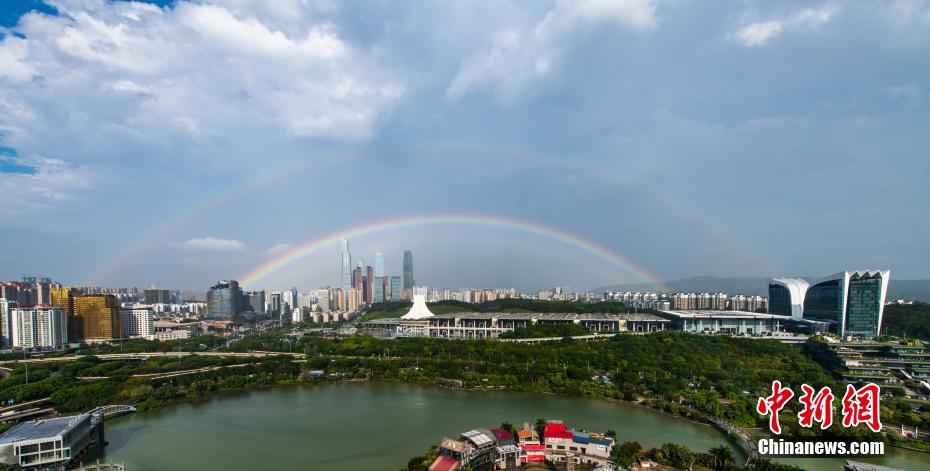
[0,414,94,469]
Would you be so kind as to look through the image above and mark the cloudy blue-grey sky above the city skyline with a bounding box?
[0,0,930,289]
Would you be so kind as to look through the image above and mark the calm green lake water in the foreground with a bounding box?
[96,383,930,471]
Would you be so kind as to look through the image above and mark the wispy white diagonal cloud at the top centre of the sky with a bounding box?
[446,0,659,102]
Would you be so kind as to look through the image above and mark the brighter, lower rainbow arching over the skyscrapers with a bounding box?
[239,215,673,291]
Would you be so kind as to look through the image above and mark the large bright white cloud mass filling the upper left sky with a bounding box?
[0,0,404,201]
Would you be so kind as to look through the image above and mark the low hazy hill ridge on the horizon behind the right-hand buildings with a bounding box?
[593,274,930,302]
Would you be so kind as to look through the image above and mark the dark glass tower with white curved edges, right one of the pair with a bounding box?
[804,270,891,338]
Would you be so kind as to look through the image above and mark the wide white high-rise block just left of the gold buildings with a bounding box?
[10,306,68,350]
